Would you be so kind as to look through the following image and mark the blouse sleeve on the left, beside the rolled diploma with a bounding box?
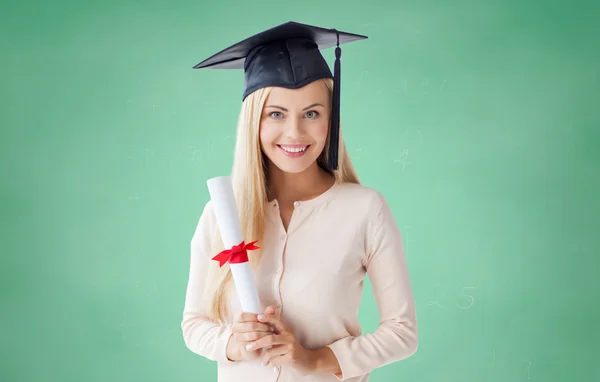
[181,201,232,363]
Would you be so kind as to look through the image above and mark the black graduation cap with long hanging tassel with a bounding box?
[194,21,367,170]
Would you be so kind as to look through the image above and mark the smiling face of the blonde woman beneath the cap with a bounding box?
[260,80,331,173]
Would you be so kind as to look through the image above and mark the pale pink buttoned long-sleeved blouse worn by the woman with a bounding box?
[181,183,418,382]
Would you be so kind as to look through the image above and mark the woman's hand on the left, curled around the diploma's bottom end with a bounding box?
[227,306,275,361]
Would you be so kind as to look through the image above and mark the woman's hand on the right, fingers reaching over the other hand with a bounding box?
[248,308,316,375]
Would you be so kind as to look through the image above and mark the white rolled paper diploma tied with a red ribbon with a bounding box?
[206,176,262,314]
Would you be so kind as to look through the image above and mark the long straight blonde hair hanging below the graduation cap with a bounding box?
[205,78,359,323]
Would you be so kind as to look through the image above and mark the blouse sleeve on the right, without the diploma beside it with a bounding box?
[329,193,418,381]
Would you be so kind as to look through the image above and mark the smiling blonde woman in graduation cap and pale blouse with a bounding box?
[181,23,418,382]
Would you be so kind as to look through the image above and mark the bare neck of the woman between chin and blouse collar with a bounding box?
[268,162,335,203]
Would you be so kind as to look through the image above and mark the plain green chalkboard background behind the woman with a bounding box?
[0,0,600,382]
